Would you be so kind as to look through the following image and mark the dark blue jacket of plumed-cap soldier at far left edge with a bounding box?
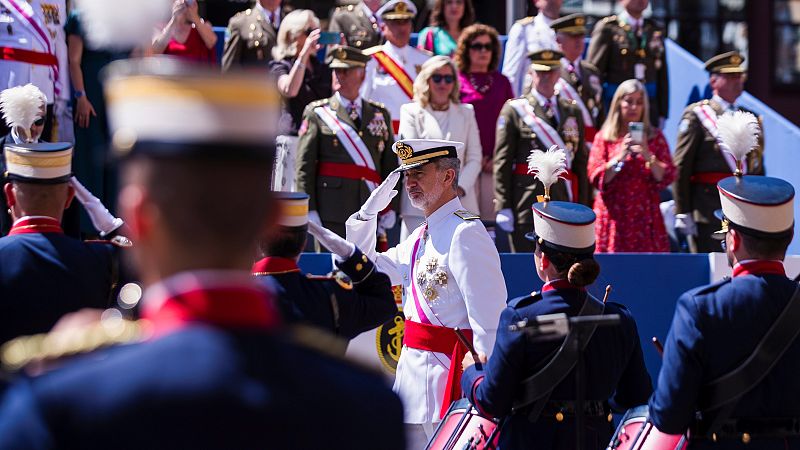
[0,233,116,342]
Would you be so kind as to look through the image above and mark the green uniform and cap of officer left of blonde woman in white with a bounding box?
[296,47,398,237]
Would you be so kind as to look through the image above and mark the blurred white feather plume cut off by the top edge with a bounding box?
[76,0,172,50]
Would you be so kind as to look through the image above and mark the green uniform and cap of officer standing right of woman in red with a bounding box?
[672,52,764,253]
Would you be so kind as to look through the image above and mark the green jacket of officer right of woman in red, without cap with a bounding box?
[672,100,764,226]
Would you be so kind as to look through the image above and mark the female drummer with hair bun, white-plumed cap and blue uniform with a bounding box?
[461,146,652,450]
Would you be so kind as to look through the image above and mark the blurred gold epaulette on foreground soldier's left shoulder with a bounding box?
[0,316,152,372]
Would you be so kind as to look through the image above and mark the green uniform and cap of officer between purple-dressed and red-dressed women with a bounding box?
[494,50,590,252]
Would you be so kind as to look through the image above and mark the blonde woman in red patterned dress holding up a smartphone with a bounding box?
[588,80,675,253]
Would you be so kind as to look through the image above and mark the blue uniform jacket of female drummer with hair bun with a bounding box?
[461,289,652,450]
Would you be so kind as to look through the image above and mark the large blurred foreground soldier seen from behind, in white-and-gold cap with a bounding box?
[0,60,403,449]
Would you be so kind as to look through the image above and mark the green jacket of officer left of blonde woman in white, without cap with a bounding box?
[296,95,398,234]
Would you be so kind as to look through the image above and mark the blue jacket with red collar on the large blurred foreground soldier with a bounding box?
[0,275,404,450]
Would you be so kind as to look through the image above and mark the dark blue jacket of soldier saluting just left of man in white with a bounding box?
[256,249,397,339]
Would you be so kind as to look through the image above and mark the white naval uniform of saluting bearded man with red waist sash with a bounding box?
[345,198,507,424]
